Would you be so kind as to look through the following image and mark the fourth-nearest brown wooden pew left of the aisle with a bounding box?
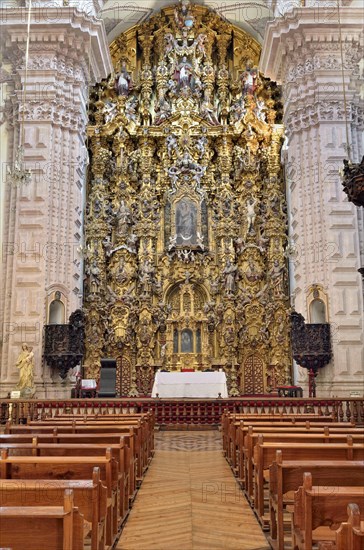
[0,437,130,524]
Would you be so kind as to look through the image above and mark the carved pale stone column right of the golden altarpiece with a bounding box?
[260,5,364,396]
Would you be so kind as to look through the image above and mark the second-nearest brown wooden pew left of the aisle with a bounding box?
[0,468,107,550]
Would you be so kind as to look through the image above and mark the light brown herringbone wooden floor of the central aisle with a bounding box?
[116,431,270,550]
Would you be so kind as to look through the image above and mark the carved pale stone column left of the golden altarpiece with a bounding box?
[0,1,112,397]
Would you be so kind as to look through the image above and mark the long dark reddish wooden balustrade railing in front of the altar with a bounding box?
[0,397,364,426]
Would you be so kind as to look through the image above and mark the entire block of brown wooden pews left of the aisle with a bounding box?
[0,413,154,550]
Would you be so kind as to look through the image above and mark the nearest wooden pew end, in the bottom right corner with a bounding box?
[332,503,364,550]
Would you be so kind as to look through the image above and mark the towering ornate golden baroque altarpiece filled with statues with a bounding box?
[84,0,291,396]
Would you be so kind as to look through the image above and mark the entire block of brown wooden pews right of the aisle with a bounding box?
[222,413,364,550]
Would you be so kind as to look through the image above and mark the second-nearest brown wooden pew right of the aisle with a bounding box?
[293,472,364,550]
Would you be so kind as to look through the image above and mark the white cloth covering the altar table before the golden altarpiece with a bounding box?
[152,372,228,398]
